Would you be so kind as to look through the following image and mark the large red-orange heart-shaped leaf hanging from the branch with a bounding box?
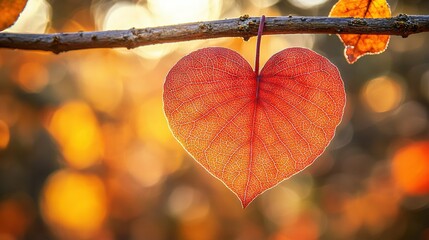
[164,48,345,207]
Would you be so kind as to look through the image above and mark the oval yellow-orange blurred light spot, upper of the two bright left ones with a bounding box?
[49,102,103,168]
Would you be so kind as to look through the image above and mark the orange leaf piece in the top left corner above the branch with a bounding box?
[0,0,27,31]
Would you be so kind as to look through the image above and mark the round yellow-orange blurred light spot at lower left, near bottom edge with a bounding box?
[42,170,107,239]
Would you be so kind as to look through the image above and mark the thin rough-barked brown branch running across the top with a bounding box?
[0,14,429,53]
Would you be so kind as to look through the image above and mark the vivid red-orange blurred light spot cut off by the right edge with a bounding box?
[392,141,429,195]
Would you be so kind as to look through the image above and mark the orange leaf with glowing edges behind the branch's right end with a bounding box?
[329,0,391,64]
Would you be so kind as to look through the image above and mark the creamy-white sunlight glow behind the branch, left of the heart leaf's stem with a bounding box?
[102,0,222,59]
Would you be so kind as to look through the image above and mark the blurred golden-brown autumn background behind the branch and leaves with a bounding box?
[0,0,429,240]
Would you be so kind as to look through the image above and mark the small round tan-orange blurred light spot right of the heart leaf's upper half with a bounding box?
[361,76,404,113]
